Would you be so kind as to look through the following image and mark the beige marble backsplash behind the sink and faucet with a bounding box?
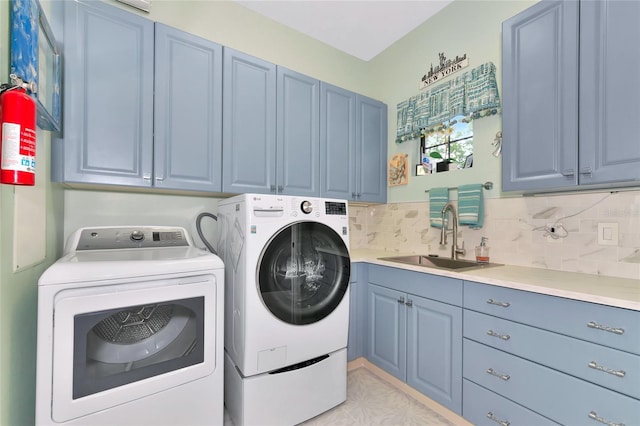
[349,191,640,279]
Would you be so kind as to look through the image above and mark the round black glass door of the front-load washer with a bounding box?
[257,222,351,325]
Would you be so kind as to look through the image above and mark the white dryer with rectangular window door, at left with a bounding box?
[36,226,224,426]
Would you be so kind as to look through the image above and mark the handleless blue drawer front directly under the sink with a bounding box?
[369,265,462,306]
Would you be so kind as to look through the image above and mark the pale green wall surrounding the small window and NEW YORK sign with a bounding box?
[370,0,535,203]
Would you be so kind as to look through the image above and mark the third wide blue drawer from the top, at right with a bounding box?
[463,338,640,425]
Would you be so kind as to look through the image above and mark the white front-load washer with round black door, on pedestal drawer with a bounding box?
[218,194,350,426]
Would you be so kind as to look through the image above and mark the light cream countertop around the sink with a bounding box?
[350,249,640,311]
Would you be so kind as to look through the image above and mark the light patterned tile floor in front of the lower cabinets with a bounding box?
[224,367,454,426]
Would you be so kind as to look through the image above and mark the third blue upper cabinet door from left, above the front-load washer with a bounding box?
[222,47,276,193]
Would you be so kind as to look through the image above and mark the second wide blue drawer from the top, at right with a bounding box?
[464,310,640,399]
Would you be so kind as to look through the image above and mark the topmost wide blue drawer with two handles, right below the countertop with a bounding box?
[464,282,640,355]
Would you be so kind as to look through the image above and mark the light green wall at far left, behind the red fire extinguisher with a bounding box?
[0,0,63,426]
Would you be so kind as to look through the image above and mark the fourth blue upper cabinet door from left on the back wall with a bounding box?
[276,67,320,197]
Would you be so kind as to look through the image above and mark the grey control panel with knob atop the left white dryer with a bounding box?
[72,226,190,251]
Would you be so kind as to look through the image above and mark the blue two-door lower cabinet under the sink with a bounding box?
[365,266,462,414]
